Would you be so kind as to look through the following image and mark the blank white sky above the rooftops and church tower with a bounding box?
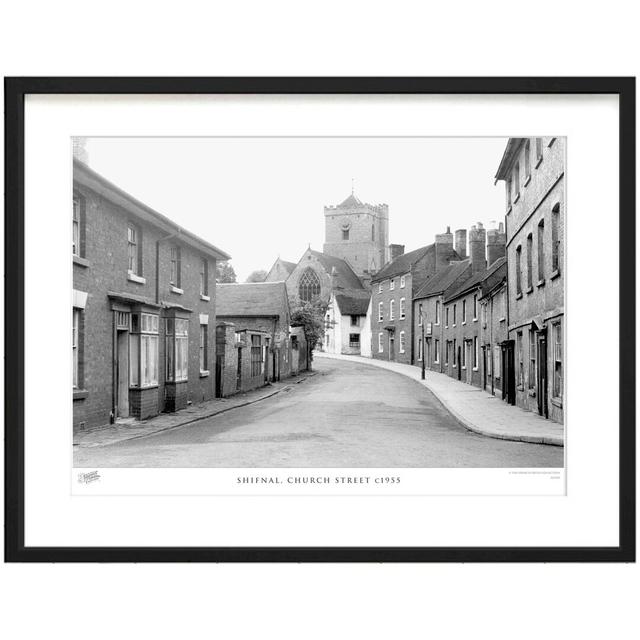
[87,138,507,282]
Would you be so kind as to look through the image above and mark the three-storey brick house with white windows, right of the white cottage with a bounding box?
[371,230,461,364]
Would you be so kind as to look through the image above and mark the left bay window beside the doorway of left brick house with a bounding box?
[129,313,159,387]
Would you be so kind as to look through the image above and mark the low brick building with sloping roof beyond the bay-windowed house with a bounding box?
[216,282,306,397]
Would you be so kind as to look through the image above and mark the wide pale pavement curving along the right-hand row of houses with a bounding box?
[314,352,564,447]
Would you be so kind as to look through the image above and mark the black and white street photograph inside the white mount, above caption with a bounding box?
[69,136,570,476]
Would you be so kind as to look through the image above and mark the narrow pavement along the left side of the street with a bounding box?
[73,371,315,448]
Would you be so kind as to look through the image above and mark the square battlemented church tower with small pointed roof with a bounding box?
[323,191,389,279]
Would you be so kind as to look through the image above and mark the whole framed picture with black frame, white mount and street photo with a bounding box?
[5,78,635,562]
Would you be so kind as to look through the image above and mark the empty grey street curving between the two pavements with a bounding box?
[74,358,563,468]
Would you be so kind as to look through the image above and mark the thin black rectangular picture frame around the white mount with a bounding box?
[4,77,636,562]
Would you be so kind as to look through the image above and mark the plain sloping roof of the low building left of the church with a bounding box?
[216,282,289,317]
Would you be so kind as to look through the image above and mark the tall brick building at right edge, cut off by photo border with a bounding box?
[496,137,565,422]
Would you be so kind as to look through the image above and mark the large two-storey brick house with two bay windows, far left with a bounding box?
[72,158,229,430]
